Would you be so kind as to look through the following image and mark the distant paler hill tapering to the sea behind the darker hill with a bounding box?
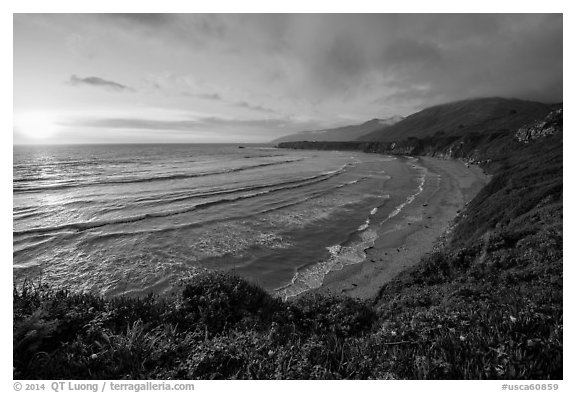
[271,116,402,143]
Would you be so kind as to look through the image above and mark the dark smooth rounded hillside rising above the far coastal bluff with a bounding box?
[358,97,550,142]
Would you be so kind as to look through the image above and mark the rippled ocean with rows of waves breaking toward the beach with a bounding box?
[13,144,426,298]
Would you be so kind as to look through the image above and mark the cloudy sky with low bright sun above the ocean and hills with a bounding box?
[13,14,563,144]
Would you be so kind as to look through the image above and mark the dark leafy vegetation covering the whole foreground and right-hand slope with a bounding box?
[13,112,563,379]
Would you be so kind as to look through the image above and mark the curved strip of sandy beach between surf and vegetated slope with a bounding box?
[317,157,489,299]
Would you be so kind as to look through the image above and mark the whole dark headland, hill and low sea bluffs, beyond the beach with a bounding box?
[277,97,563,170]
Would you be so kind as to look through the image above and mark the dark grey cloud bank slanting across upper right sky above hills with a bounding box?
[106,14,563,109]
